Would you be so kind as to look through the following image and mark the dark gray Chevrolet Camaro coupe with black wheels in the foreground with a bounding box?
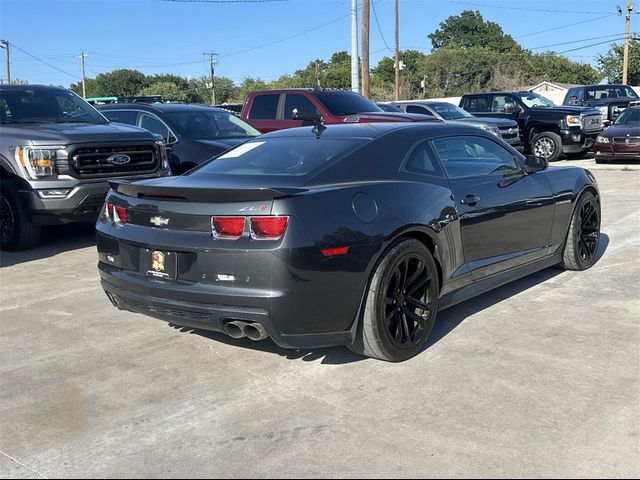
[97,123,600,361]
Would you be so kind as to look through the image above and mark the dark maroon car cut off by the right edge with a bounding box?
[595,107,640,163]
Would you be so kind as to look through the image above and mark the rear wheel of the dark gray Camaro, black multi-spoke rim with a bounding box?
[349,239,440,362]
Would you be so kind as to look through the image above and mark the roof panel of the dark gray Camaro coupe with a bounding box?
[258,122,483,139]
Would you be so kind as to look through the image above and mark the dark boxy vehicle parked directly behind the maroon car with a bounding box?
[562,85,640,122]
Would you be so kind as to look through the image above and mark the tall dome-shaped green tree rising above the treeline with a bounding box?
[428,10,522,53]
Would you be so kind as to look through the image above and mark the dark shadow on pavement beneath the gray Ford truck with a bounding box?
[0,223,97,268]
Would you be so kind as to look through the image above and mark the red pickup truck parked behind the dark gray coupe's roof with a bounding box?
[240,88,438,133]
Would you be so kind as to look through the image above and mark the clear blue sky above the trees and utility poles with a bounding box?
[0,0,640,86]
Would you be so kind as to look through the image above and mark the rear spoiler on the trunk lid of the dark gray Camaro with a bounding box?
[109,180,307,202]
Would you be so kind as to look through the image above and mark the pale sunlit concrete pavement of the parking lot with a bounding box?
[0,160,640,478]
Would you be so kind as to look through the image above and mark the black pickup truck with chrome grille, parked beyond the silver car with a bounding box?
[460,92,603,162]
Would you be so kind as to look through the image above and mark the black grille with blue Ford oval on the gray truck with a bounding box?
[69,145,159,178]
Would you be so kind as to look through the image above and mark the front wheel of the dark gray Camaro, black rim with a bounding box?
[560,192,600,270]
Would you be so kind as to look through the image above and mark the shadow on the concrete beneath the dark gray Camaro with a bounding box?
[162,234,609,365]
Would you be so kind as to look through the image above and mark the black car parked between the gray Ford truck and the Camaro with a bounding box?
[99,103,260,175]
